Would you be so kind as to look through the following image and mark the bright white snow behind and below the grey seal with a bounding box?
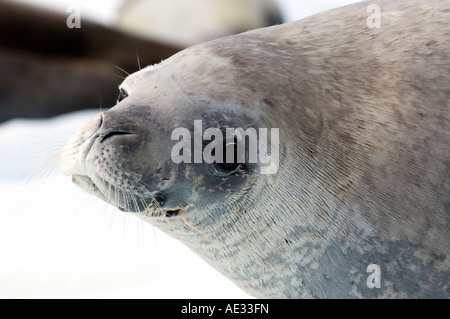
[0,0,354,298]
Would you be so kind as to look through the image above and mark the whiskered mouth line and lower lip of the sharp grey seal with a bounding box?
[72,175,184,218]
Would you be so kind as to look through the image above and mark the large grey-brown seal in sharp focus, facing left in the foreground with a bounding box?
[61,0,450,298]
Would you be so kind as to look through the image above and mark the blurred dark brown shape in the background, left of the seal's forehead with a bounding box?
[0,1,180,122]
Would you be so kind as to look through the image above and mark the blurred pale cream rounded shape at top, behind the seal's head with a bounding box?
[117,0,282,47]
